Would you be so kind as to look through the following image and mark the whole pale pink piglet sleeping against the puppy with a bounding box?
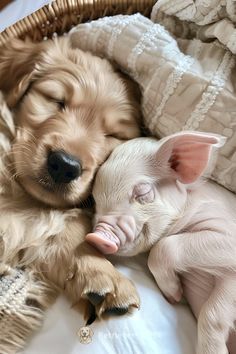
[86,132,236,354]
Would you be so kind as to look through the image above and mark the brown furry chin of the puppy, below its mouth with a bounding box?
[18,177,89,208]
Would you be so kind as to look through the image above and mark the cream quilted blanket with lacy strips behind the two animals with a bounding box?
[71,0,236,192]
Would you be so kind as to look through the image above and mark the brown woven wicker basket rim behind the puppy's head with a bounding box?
[0,0,156,46]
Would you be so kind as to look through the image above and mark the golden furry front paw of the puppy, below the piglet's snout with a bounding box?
[66,246,140,318]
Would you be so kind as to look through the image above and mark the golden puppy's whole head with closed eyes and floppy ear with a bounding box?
[0,39,139,207]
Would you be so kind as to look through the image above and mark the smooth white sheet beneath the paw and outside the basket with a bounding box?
[0,0,196,354]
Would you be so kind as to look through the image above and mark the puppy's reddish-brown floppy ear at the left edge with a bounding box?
[0,39,45,107]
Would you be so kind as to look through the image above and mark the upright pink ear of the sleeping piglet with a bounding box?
[158,132,225,184]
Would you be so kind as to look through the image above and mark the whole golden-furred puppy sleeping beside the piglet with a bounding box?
[0,38,140,353]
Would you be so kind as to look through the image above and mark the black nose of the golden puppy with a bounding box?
[47,151,82,183]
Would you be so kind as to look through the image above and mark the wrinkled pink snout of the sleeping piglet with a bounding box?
[85,215,136,254]
